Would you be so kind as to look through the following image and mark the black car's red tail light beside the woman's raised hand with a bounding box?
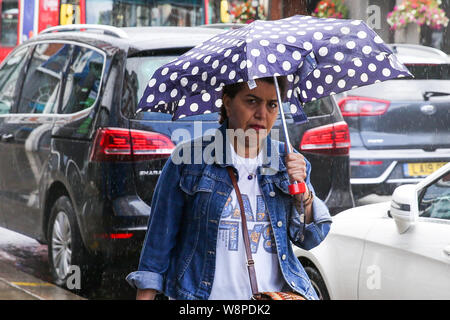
[300,121,350,155]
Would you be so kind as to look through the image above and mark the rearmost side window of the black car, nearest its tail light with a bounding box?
[59,46,105,114]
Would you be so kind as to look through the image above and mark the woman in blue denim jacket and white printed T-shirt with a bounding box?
[127,78,331,300]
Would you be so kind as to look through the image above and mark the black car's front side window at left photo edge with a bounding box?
[0,47,28,114]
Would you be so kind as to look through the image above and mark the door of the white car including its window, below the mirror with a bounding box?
[359,173,450,299]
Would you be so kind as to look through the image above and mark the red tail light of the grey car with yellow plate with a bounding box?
[338,97,390,117]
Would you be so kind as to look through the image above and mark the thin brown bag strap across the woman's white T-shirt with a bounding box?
[227,167,259,296]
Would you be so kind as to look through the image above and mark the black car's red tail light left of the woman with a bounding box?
[90,128,175,161]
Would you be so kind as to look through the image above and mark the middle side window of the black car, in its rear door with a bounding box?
[18,43,72,113]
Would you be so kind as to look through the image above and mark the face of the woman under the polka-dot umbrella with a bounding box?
[223,80,278,140]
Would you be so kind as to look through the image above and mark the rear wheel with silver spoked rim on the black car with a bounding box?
[47,196,102,294]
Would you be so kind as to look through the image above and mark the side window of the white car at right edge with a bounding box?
[419,172,450,220]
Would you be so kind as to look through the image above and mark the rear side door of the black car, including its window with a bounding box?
[5,42,73,237]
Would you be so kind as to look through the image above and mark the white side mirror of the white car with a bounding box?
[391,184,418,233]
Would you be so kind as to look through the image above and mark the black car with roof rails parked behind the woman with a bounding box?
[0,25,353,290]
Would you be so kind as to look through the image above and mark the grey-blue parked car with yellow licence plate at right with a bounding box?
[336,44,450,197]
